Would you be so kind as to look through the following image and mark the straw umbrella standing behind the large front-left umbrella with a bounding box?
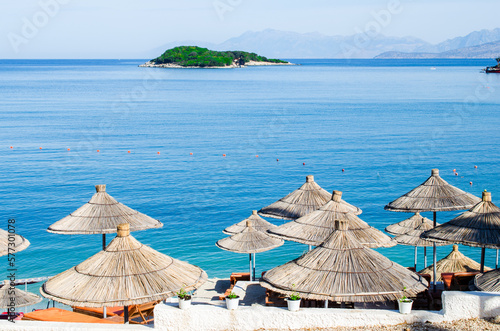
[47,185,163,249]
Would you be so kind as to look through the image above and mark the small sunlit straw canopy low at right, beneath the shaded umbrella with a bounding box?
[419,245,491,281]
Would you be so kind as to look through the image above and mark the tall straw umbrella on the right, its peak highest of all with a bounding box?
[384,169,480,287]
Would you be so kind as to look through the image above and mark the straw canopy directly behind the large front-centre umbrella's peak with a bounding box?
[268,191,396,248]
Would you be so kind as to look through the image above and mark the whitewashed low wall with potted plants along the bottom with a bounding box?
[155,291,500,331]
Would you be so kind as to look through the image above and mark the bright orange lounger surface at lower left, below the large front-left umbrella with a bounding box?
[23,308,119,324]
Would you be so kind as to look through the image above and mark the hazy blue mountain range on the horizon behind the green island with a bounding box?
[146,28,500,59]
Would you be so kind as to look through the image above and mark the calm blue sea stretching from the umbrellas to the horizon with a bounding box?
[0,60,500,300]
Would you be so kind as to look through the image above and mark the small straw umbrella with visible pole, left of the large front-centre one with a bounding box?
[215,220,284,280]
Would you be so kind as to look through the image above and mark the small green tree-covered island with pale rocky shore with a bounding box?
[139,46,293,68]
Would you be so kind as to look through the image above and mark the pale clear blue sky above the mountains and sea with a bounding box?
[0,0,500,59]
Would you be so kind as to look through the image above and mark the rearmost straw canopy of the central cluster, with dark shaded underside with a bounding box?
[259,175,361,220]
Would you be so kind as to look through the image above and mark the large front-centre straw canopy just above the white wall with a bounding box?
[261,220,427,302]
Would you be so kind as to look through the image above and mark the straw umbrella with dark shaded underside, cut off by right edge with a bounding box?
[423,191,500,272]
